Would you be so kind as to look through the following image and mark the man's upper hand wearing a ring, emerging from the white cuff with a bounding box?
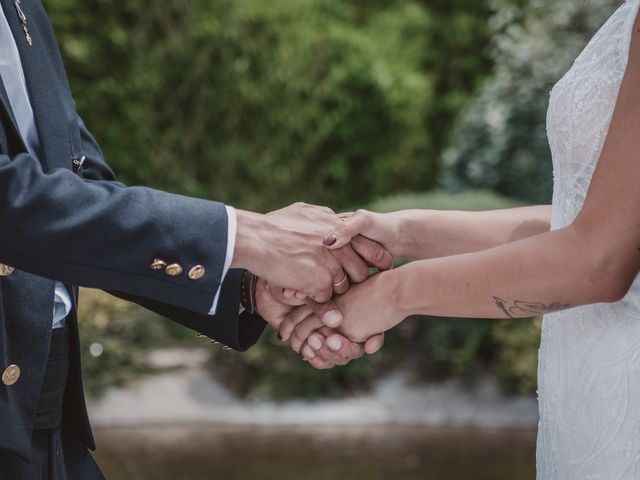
[232,203,392,303]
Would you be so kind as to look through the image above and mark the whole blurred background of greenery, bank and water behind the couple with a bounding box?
[50,0,620,480]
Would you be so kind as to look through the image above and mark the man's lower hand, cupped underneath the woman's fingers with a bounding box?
[256,279,382,369]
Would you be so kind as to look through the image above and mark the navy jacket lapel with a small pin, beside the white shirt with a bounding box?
[0,0,71,169]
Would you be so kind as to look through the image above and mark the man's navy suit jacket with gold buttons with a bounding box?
[0,0,265,472]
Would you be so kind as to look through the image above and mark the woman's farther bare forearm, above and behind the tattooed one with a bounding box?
[386,205,551,259]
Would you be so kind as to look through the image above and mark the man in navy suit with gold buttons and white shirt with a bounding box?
[0,0,390,480]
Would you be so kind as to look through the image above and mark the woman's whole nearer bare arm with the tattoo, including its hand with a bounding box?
[284,17,640,348]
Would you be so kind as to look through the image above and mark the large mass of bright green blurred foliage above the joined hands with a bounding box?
[47,0,491,210]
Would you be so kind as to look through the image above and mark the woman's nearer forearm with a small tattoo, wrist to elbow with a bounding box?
[381,222,634,318]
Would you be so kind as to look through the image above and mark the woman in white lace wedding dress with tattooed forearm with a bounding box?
[280,0,640,480]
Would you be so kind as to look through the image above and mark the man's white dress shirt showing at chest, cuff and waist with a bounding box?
[0,7,237,328]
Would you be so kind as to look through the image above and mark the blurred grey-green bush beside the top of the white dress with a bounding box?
[443,0,619,203]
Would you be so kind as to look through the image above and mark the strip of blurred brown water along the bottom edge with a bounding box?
[96,425,535,480]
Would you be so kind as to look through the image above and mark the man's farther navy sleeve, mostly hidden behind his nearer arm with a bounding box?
[78,117,266,351]
